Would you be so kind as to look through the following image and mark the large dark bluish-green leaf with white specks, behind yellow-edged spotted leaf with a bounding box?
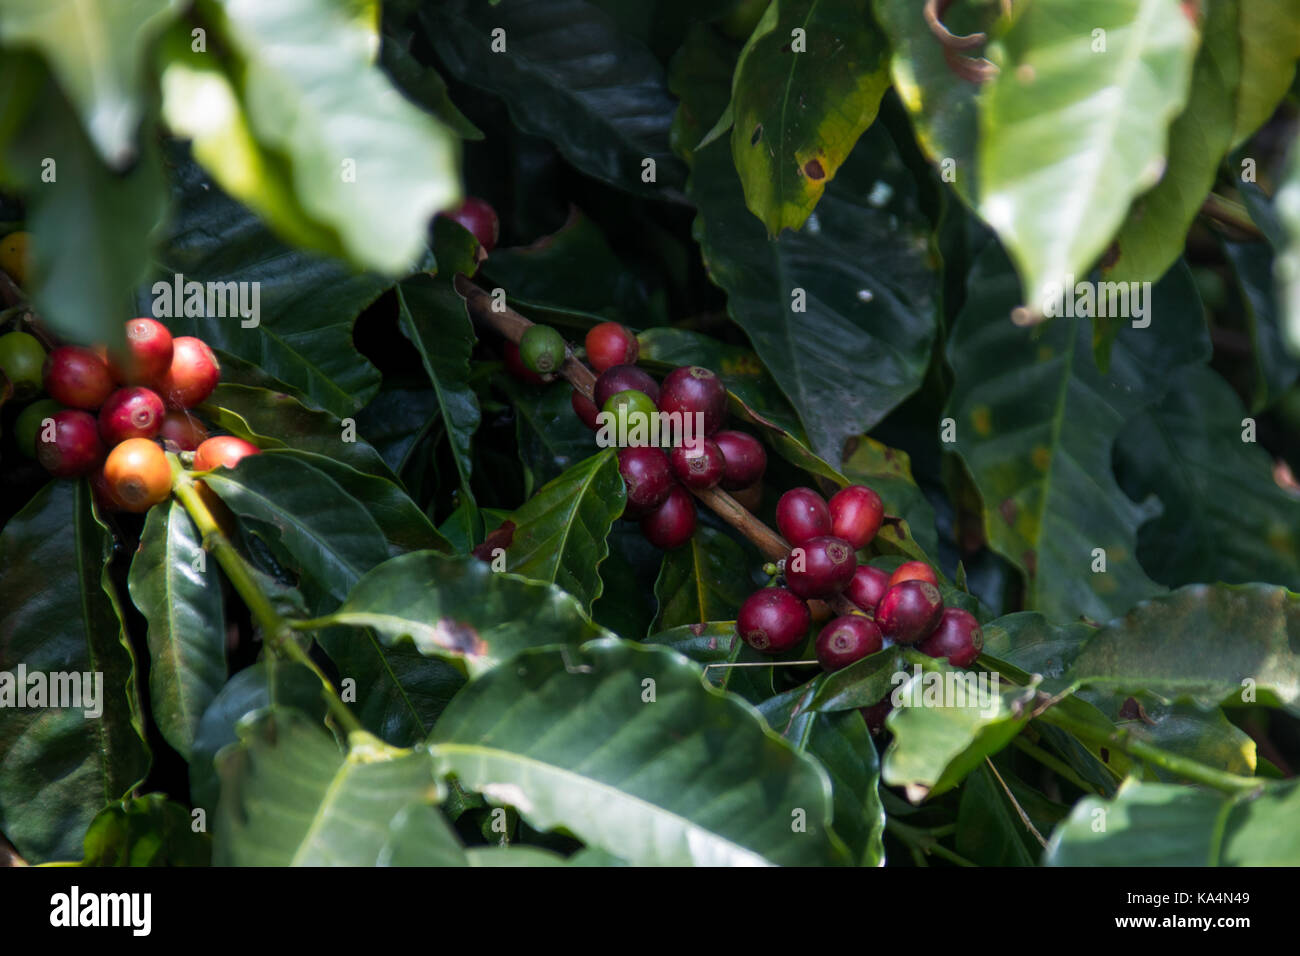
[673,27,936,464]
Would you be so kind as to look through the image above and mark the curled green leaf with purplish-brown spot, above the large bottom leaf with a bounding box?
[306,551,606,674]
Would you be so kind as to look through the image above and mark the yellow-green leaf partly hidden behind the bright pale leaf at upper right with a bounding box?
[1105,0,1242,282]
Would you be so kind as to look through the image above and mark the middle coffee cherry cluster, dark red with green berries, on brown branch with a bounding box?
[506,323,767,550]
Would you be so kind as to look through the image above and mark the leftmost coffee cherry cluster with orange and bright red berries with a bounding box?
[0,319,259,512]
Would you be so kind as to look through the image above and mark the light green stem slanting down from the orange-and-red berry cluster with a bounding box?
[169,468,365,734]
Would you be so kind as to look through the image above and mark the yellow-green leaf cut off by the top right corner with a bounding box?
[1232,0,1300,148]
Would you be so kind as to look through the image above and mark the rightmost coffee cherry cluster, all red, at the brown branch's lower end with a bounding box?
[736,485,984,671]
